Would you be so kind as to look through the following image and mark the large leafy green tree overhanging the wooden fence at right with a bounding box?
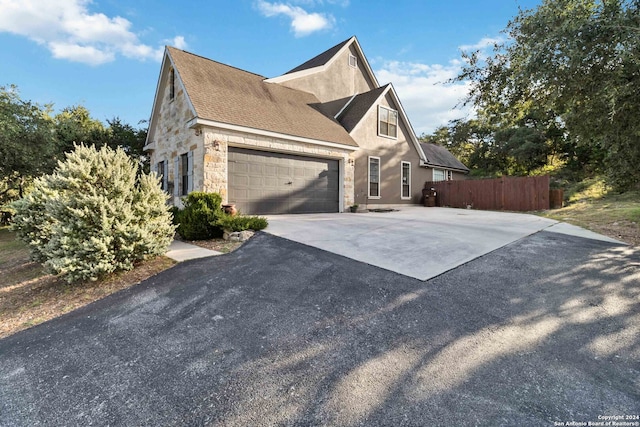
[458,0,640,189]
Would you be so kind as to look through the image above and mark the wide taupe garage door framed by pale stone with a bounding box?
[228,147,340,214]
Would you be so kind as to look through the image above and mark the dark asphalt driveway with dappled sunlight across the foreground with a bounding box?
[0,231,640,426]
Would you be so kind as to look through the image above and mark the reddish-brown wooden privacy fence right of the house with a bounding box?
[425,175,549,211]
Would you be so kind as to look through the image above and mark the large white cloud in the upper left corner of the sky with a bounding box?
[0,0,186,65]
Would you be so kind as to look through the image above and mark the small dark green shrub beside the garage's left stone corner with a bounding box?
[176,191,224,240]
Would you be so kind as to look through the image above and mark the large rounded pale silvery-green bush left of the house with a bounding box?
[12,145,175,282]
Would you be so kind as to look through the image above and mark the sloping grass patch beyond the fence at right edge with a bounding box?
[542,180,640,246]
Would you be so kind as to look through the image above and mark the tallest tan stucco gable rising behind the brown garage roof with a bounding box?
[267,37,379,103]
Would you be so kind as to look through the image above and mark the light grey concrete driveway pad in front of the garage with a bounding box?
[265,206,620,280]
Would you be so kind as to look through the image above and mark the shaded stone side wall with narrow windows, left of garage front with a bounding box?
[151,73,204,206]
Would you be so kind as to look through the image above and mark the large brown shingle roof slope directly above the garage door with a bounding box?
[167,47,358,147]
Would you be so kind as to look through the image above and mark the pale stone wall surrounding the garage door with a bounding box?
[201,128,354,210]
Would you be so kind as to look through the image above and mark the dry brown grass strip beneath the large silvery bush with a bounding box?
[0,227,175,338]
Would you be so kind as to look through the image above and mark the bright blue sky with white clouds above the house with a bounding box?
[0,0,540,135]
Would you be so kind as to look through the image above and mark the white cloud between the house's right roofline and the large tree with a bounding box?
[375,60,473,135]
